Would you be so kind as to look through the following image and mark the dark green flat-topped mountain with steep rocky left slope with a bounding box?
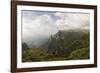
[47,30,89,55]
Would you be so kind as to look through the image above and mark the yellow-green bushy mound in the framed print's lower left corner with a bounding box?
[22,48,47,62]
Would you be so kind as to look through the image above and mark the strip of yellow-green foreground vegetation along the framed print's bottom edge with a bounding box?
[22,48,89,62]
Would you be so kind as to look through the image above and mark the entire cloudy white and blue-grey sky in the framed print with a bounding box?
[22,10,90,45]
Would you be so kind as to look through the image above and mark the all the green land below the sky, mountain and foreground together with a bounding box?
[22,31,89,62]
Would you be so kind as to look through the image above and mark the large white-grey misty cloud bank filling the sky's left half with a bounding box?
[22,12,58,46]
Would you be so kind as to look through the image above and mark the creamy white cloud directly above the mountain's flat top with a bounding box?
[55,12,90,30]
